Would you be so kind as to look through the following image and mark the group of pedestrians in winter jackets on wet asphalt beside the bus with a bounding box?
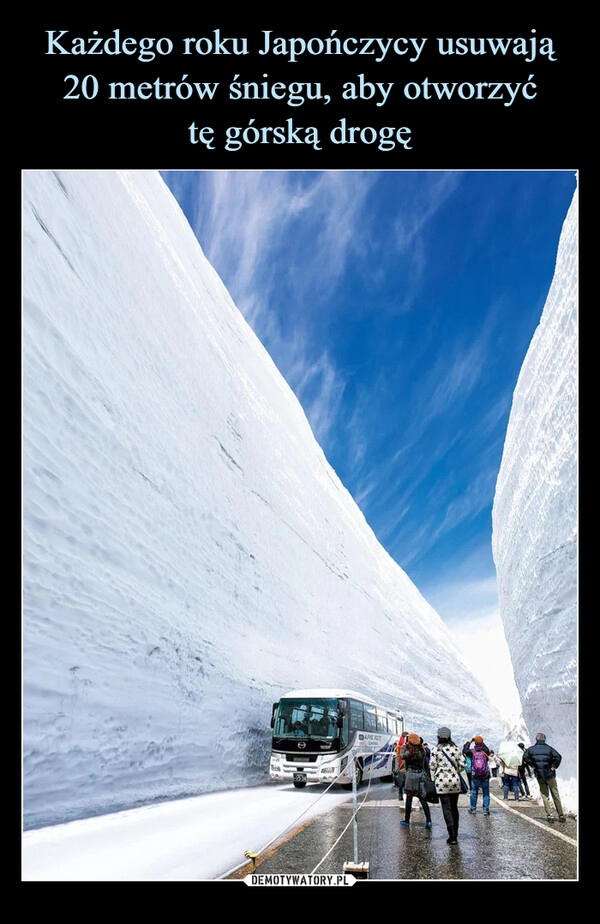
[396,725,565,844]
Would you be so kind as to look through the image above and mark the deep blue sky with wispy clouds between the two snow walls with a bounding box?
[162,170,576,640]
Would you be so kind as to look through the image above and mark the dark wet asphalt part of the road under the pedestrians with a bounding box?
[227,780,578,885]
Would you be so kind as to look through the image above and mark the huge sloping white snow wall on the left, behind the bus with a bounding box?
[23,171,502,827]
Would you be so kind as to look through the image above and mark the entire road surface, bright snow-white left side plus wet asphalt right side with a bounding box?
[22,781,578,884]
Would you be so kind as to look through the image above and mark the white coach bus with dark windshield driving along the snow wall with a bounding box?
[269,689,404,789]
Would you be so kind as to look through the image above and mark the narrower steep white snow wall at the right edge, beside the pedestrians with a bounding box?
[492,184,578,801]
